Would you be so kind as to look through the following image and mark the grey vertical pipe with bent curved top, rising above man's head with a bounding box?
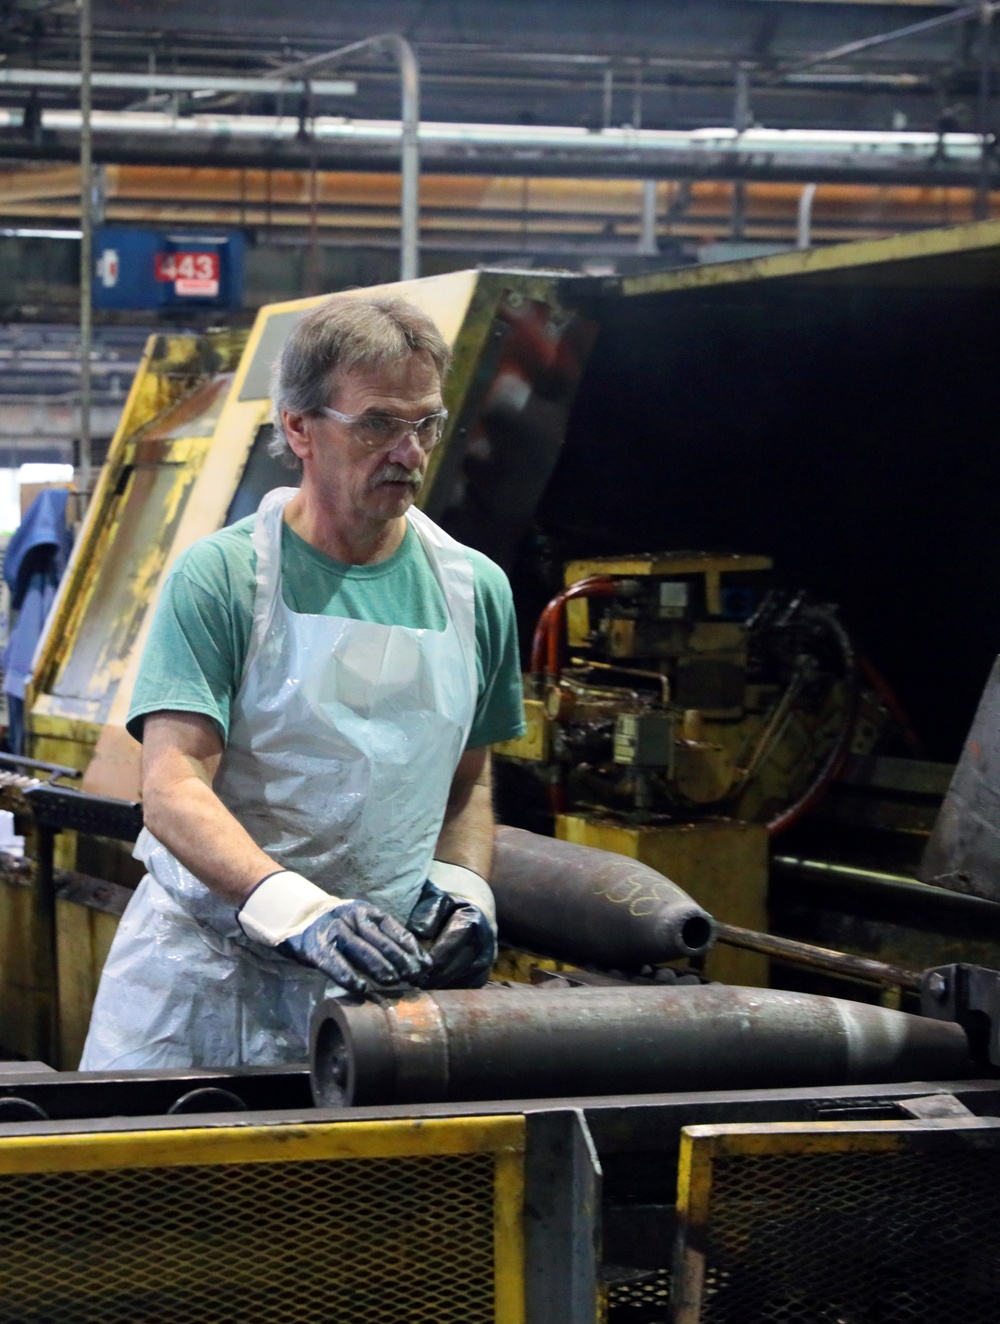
[267,32,420,281]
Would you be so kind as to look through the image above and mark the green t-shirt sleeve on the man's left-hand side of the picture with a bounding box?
[126,560,238,740]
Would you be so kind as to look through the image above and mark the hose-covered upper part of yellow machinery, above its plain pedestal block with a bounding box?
[499,553,886,833]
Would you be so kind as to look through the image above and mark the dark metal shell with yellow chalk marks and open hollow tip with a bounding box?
[490,828,714,970]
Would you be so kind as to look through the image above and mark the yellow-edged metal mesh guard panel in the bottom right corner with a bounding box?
[699,1144,1000,1324]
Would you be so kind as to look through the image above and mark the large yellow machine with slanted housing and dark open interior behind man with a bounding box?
[0,224,1000,1059]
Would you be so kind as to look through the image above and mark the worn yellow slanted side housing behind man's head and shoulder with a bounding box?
[30,271,588,800]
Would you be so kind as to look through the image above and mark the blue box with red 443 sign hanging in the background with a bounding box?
[91,225,246,310]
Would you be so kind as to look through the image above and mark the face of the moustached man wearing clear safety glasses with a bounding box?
[302,351,442,522]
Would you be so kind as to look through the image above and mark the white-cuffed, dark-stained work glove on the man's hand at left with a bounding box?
[243,870,430,996]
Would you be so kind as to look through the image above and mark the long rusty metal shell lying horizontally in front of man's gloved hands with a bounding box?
[313,984,976,1107]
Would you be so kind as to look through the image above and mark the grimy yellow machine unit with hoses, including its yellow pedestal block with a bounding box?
[497,552,905,984]
